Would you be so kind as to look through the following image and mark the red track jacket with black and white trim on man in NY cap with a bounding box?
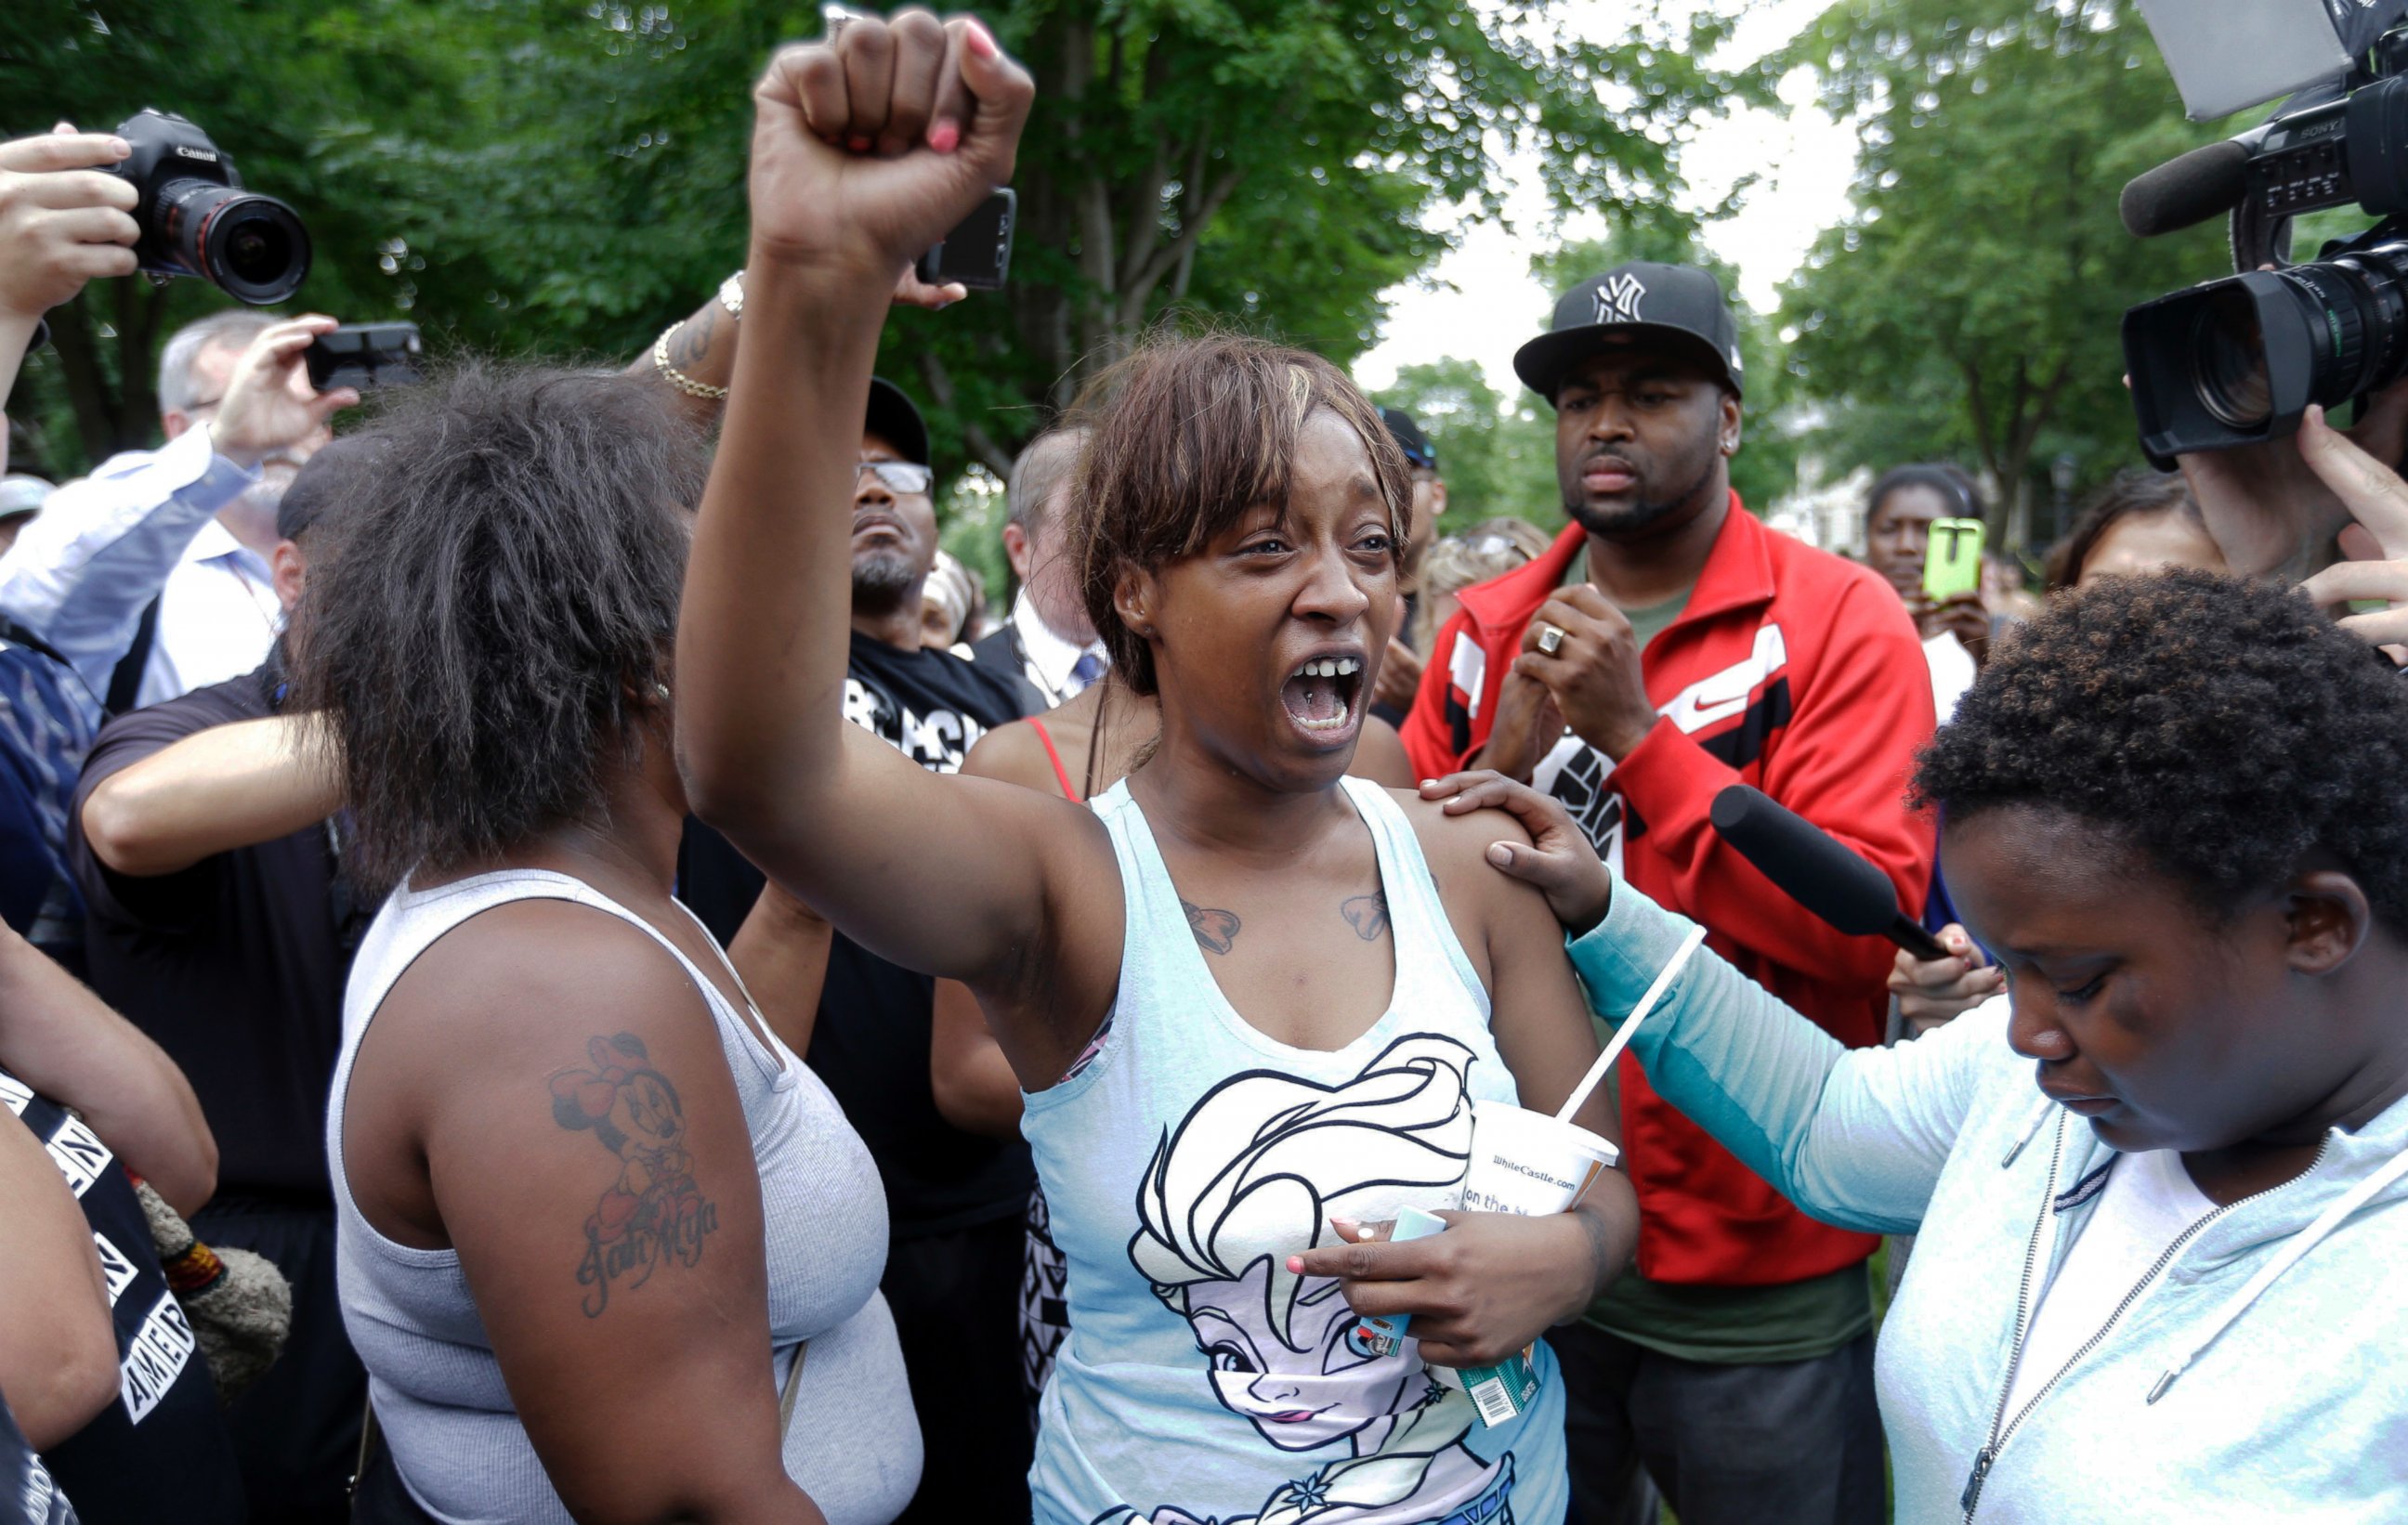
[1404,491,1933,1286]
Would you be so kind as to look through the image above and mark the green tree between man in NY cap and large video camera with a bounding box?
[1782,0,2222,544]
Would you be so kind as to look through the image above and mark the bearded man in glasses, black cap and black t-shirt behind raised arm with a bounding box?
[676,381,1036,1520]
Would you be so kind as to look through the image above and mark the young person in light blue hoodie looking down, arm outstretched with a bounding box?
[1425,573,2408,1525]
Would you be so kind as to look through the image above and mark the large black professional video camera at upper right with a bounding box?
[2124,29,2408,465]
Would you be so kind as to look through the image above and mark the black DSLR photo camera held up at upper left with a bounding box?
[113,109,310,306]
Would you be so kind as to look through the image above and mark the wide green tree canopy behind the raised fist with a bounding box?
[0,0,1756,486]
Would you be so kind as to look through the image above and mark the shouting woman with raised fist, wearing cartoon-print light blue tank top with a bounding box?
[676,17,1638,1525]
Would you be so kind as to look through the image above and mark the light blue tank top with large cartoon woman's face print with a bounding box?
[1021,778,1567,1525]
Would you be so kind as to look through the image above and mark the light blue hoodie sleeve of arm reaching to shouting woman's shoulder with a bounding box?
[1570,880,2013,1233]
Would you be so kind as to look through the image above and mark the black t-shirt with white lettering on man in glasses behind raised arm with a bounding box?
[676,632,1036,1238]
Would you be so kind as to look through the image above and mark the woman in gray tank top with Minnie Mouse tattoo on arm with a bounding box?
[294,369,920,1525]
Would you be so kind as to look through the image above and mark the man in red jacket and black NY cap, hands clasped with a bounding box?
[1404,263,1931,1525]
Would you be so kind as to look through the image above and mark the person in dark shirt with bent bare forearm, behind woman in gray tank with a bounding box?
[68,438,375,1525]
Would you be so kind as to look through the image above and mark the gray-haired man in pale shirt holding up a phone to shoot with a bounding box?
[0,308,359,713]
